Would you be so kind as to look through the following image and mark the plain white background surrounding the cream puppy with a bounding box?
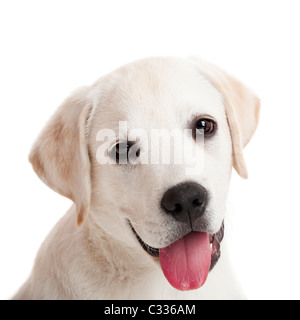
[0,0,300,299]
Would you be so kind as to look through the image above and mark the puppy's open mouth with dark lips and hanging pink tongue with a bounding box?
[129,221,224,291]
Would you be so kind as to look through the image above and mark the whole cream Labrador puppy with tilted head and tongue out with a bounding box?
[14,57,260,299]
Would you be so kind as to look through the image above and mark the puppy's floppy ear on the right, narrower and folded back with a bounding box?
[192,58,260,179]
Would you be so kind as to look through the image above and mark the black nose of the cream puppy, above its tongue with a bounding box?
[161,182,207,225]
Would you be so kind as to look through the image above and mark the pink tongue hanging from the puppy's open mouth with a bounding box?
[159,232,211,291]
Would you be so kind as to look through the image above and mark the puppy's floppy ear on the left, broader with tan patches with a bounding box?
[29,88,91,226]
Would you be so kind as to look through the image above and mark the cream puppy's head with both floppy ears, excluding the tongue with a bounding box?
[30,58,259,292]
